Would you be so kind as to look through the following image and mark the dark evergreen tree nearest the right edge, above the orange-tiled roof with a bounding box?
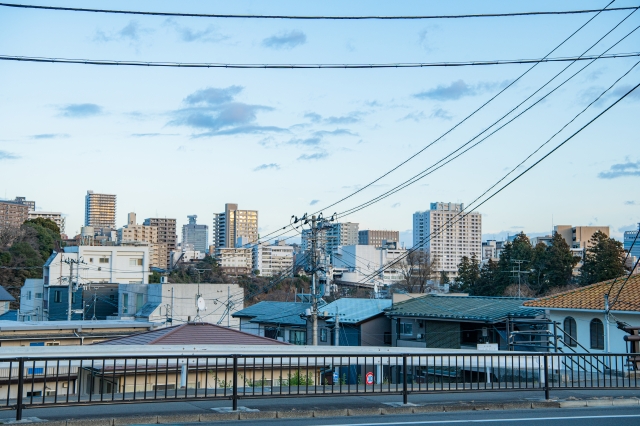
[580,231,626,285]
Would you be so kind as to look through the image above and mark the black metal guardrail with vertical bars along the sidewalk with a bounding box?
[0,352,640,420]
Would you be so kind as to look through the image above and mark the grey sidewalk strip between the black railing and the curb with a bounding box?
[0,389,640,426]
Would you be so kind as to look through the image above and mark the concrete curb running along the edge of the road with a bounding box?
[0,398,640,426]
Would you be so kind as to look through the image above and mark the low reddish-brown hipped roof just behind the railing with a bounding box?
[96,322,288,345]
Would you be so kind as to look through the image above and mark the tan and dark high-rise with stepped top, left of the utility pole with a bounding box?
[213,203,258,249]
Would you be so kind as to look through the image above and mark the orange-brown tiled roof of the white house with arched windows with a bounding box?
[523,275,640,312]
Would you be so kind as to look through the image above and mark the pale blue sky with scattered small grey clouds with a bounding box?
[0,0,640,246]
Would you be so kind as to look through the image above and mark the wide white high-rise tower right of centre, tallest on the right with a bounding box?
[413,203,482,279]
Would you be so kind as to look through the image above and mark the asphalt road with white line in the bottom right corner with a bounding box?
[140,407,640,426]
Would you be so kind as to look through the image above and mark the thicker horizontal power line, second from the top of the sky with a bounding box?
[0,52,640,69]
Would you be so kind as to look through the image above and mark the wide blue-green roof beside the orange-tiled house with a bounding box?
[387,295,542,322]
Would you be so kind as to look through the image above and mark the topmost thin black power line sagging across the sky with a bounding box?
[0,3,634,20]
